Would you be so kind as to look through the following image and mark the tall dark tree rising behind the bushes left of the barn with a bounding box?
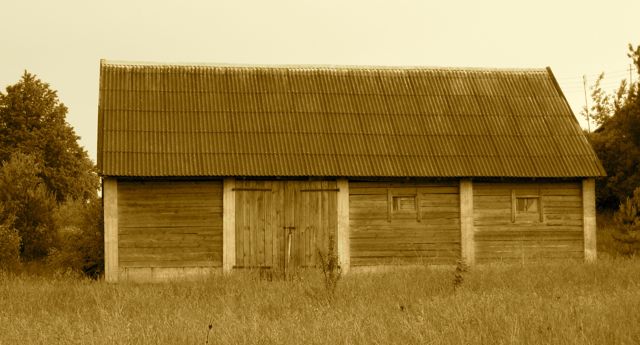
[0,71,99,202]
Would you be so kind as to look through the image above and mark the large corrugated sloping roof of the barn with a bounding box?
[98,61,605,177]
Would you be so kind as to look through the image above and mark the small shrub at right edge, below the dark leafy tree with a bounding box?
[613,188,640,256]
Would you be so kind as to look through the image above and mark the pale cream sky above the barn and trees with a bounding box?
[0,0,640,161]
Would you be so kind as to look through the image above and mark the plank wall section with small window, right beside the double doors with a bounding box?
[349,181,460,266]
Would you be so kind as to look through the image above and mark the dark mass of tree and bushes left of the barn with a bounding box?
[0,71,102,266]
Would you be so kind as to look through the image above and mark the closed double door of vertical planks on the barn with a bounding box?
[234,180,338,269]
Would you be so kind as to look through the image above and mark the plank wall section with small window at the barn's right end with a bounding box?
[473,181,584,262]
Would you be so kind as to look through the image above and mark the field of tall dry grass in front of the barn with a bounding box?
[0,258,640,344]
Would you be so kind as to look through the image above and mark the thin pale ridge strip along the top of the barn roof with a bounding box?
[100,59,548,72]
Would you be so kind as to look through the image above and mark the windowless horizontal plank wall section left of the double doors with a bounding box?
[118,181,222,271]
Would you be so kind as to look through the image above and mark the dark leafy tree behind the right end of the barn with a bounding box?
[588,45,640,209]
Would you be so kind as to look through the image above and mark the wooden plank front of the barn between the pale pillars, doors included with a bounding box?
[105,180,586,279]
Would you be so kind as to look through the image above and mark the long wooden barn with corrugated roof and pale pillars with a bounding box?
[98,60,605,281]
